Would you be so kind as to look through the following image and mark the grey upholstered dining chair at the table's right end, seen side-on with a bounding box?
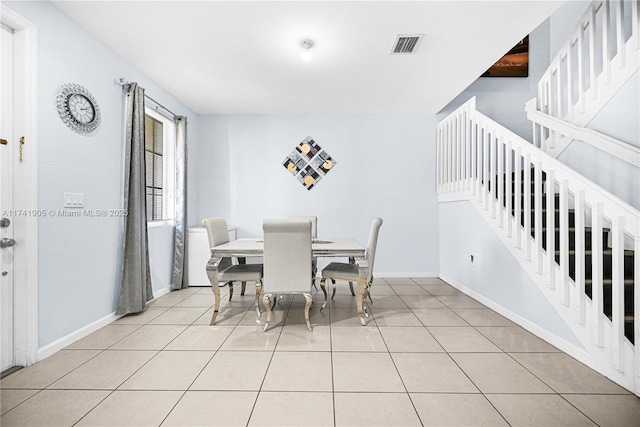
[320,218,382,325]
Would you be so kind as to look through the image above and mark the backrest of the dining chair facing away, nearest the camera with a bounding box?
[262,219,312,294]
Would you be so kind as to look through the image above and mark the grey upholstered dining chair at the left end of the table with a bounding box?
[202,218,262,325]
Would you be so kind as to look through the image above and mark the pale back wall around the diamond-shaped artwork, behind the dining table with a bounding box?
[198,116,438,275]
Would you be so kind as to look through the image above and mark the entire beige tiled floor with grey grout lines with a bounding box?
[0,278,640,427]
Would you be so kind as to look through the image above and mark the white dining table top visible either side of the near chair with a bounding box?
[211,238,365,257]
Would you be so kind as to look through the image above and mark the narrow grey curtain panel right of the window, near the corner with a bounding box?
[171,116,189,289]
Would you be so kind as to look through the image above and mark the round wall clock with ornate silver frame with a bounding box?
[56,83,100,136]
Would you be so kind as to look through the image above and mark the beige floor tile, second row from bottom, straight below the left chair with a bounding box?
[190,351,273,391]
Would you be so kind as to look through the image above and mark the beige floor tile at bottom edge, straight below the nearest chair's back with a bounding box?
[247,391,333,427]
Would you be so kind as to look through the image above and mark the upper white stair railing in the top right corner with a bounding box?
[527,0,640,157]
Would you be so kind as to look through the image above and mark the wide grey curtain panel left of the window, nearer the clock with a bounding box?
[116,83,153,314]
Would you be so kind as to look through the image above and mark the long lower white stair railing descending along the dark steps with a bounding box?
[437,97,640,394]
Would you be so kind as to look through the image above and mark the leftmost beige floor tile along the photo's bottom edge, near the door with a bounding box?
[0,390,109,427]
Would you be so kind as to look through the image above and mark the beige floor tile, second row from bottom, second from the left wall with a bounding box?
[49,350,157,390]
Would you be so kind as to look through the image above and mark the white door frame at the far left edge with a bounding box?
[0,4,38,366]
